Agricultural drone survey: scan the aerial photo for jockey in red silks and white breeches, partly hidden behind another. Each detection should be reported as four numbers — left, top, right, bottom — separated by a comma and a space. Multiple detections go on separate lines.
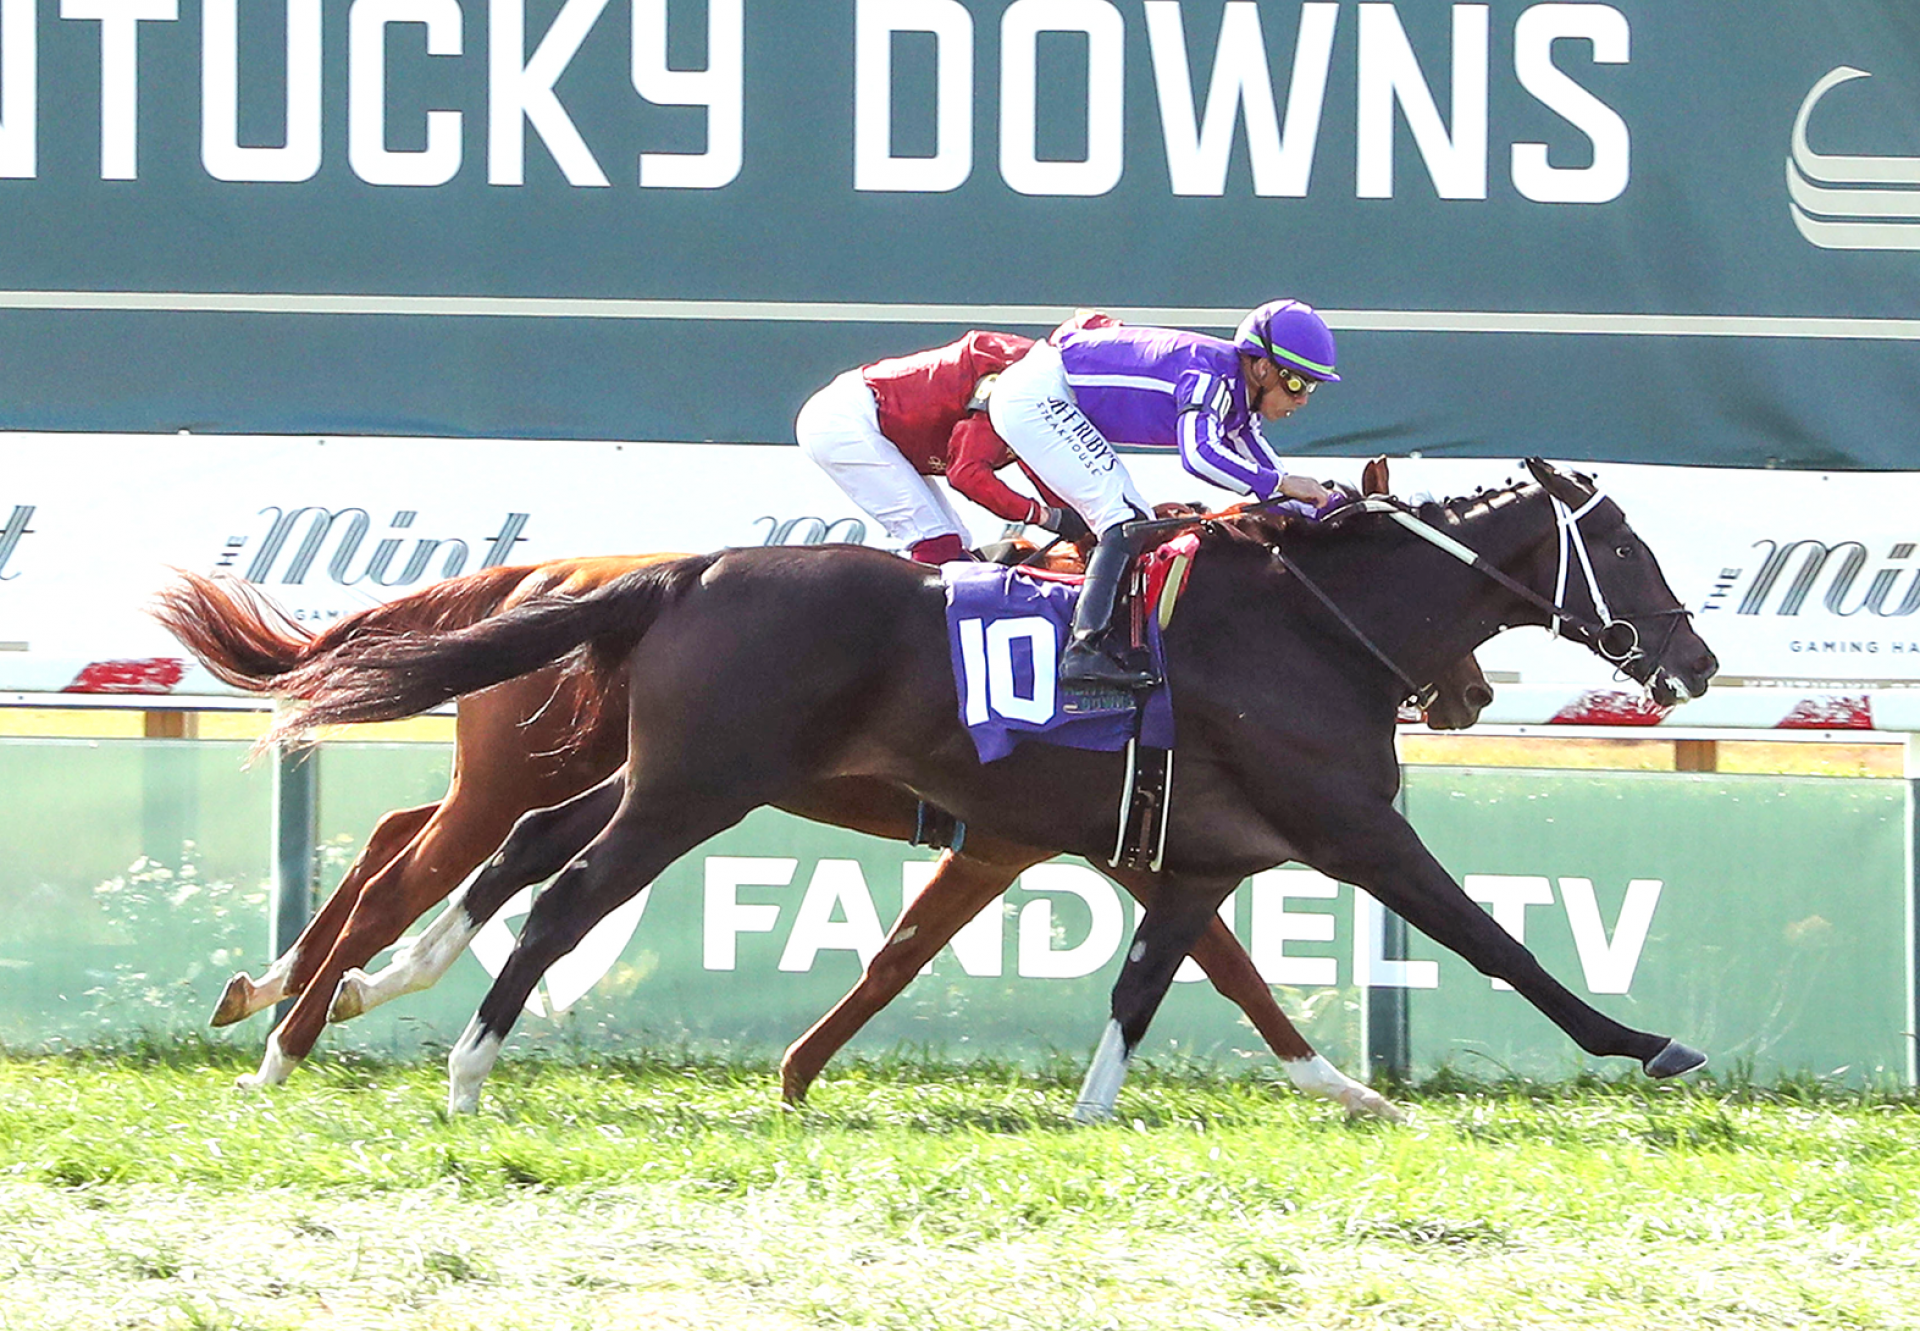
793, 313, 1112, 565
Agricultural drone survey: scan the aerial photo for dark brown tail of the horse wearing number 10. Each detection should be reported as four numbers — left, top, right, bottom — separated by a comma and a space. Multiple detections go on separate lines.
263, 555, 716, 743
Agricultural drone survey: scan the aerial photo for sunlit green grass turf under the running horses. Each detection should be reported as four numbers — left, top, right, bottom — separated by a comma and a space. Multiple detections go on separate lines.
0, 1049, 1920, 1331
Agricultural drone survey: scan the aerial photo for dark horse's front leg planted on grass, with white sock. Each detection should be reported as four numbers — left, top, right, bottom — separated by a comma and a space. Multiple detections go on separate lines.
1073, 874, 1238, 1124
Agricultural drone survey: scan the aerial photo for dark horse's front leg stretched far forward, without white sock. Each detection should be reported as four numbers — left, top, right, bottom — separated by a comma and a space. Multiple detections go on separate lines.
1296, 805, 1707, 1077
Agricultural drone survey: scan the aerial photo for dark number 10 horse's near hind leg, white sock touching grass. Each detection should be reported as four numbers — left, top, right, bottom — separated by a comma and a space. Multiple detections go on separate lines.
447, 787, 766, 1114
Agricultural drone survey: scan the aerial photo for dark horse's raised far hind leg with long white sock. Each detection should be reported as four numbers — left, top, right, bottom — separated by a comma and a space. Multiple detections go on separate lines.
328, 770, 626, 1022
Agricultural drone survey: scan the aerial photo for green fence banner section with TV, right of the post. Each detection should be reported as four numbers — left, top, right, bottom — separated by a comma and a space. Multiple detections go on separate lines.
1407, 768, 1912, 1081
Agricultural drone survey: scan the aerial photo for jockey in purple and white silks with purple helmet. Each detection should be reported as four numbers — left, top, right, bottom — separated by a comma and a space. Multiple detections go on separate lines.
989, 300, 1340, 690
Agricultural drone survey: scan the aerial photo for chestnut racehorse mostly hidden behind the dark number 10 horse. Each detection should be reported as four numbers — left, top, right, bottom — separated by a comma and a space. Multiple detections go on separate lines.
157, 545, 1492, 1114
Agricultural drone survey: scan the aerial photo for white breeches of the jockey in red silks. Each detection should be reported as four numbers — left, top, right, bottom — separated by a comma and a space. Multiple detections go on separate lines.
793, 371, 973, 545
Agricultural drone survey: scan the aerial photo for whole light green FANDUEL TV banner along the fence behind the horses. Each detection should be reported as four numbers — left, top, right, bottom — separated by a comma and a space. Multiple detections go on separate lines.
0, 741, 1910, 1081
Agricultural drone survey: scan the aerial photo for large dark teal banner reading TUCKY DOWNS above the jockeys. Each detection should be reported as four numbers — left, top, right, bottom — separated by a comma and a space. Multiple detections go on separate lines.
0, 0, 1920, 469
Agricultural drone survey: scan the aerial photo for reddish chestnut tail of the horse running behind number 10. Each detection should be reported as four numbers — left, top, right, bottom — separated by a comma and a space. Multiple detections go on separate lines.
152, 567, 549, 693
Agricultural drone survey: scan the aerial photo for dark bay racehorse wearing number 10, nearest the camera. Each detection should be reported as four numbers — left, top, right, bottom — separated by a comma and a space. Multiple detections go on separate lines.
263, 459, 1716, 1116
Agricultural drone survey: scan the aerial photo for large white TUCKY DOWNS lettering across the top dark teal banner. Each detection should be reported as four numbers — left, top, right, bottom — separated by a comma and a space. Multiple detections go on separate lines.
0, 0, 1632, 204
